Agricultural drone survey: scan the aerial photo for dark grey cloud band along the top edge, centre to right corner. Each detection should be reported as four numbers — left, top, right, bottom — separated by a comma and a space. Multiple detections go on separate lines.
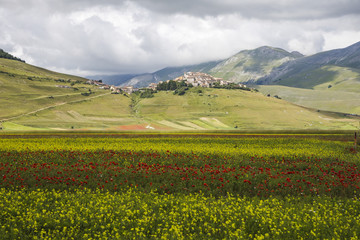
130, 0, 360, 19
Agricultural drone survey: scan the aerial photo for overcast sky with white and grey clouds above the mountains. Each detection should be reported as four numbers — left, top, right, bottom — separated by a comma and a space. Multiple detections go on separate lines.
0, 0, 360, 76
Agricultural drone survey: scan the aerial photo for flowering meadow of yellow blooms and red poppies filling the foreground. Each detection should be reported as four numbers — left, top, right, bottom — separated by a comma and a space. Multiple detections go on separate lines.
0, 133, 360, 239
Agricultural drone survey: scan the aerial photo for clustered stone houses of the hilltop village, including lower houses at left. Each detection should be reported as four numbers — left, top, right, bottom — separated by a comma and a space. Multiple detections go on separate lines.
86, 72, 246, 94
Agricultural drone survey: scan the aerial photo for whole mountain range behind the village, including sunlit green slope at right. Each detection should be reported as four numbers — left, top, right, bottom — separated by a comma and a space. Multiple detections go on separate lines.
88, 42, 360, 115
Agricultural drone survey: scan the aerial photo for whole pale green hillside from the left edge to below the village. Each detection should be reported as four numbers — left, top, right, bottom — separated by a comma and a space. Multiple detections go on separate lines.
0, 59, 358, 130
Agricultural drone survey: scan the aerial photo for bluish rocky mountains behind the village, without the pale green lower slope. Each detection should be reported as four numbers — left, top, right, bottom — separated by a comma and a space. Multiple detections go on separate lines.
96, 42, 360, 92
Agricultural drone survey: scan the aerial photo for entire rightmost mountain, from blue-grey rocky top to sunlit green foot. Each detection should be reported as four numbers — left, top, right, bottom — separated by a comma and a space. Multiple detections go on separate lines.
253, 42, 360, 115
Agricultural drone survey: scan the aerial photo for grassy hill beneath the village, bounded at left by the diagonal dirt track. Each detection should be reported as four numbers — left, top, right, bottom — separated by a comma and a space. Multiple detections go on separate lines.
3, 88, 358, 130
